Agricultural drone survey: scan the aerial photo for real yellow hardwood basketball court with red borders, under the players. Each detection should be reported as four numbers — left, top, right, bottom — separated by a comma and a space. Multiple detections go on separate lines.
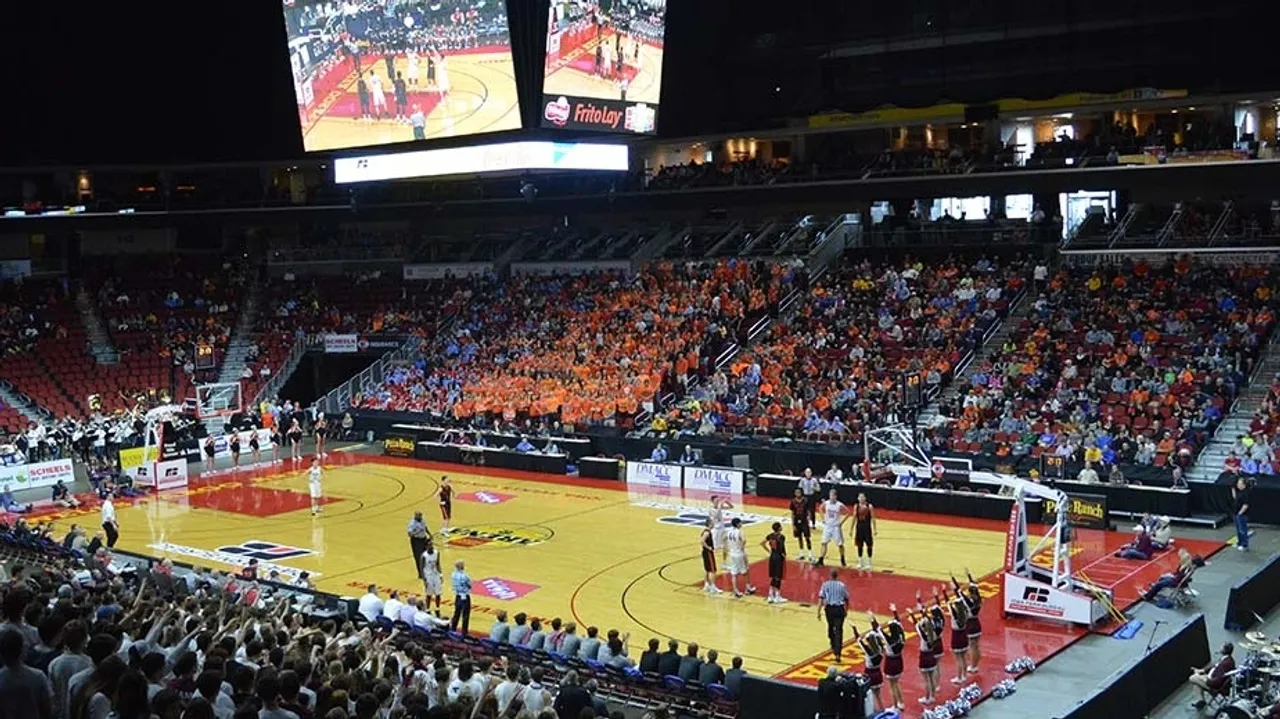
20, 452, 1224, 706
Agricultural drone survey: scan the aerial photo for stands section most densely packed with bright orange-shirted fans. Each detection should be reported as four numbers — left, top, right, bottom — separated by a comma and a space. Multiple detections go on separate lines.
362, 261, 796, 425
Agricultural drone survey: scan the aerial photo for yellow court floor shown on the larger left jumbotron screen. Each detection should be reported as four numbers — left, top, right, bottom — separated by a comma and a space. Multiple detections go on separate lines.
303, 52, 520, 150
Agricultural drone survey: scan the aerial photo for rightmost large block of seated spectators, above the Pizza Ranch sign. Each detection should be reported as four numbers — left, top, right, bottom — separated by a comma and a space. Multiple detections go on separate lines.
933, 258, 1276, 468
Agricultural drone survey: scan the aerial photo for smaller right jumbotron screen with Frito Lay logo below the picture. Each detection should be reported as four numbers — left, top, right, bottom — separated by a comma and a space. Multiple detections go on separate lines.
543, 0, 667, 133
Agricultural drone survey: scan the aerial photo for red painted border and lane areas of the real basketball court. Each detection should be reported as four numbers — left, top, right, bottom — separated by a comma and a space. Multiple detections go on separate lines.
10, 453, 1225, 709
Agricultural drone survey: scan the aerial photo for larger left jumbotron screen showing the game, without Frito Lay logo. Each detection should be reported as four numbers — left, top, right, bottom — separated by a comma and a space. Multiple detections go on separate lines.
283, 0, 521, 152
